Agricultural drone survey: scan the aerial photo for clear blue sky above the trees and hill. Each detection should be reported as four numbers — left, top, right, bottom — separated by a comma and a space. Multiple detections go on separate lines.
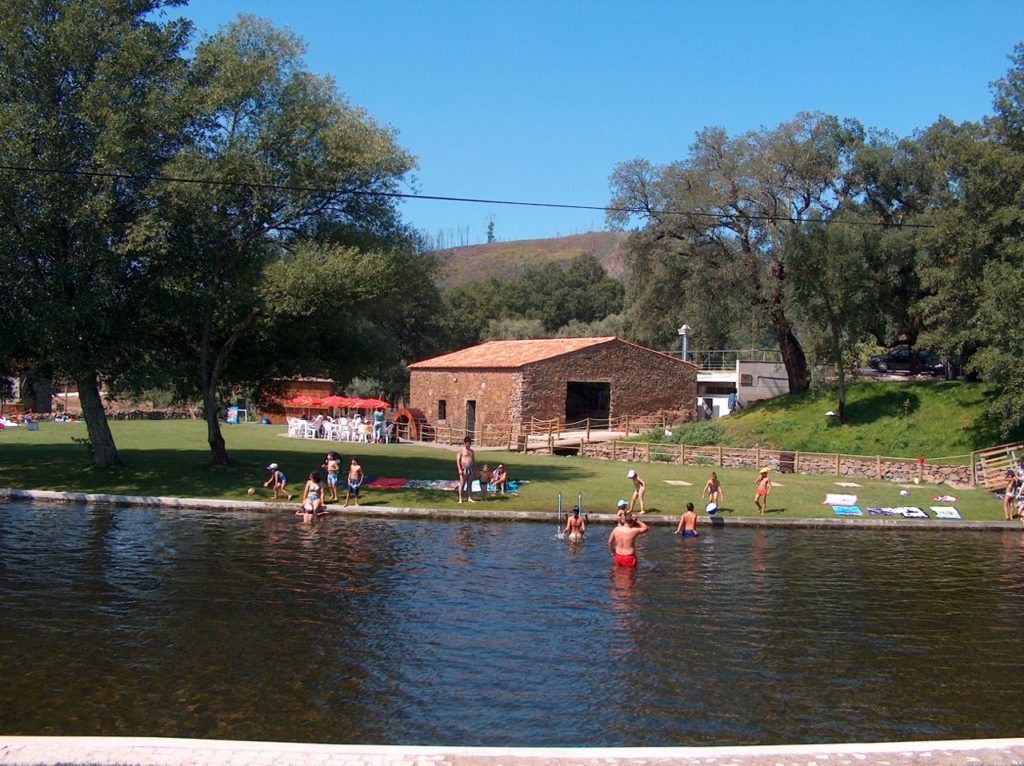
176, 0, 1024, 244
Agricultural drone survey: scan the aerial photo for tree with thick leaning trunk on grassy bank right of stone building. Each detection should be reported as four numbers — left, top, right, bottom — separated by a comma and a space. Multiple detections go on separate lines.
608, 114, 864, 392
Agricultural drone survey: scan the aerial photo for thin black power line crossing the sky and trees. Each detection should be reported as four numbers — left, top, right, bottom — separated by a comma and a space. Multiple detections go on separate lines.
0, 164, 935, 228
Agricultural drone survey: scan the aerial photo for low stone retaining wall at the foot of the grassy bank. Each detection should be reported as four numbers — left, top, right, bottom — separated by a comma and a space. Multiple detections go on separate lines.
582, 441, 973, 485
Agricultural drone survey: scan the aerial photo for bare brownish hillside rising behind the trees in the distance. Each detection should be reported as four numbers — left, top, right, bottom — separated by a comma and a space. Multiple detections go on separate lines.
436, 231, 630, 290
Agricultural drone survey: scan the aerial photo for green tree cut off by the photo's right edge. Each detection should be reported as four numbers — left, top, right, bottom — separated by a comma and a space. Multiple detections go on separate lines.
921, 44, 1024, 433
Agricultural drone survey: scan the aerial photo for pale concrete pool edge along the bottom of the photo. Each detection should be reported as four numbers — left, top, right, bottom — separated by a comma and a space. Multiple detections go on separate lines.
0, 736, 1024, 766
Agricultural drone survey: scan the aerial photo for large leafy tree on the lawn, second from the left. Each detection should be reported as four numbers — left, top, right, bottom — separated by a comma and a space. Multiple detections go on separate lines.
130, 15, 414, 464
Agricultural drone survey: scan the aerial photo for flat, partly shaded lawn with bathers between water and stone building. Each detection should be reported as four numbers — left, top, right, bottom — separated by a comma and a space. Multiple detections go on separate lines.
0, 421, 1002, 523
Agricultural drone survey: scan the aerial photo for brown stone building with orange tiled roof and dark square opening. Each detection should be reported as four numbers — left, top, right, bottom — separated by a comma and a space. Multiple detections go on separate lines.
410, 337, 696, 434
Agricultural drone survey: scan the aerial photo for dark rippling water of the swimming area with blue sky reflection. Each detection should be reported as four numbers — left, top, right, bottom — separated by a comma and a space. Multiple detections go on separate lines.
0, 504, 1024, 746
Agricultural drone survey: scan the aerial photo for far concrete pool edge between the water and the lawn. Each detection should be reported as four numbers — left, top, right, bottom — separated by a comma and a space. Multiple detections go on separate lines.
0, 487, 1024, 534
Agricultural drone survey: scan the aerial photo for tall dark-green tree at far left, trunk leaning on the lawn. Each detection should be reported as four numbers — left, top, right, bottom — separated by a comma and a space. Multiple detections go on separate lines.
0, 0, 189, 466
